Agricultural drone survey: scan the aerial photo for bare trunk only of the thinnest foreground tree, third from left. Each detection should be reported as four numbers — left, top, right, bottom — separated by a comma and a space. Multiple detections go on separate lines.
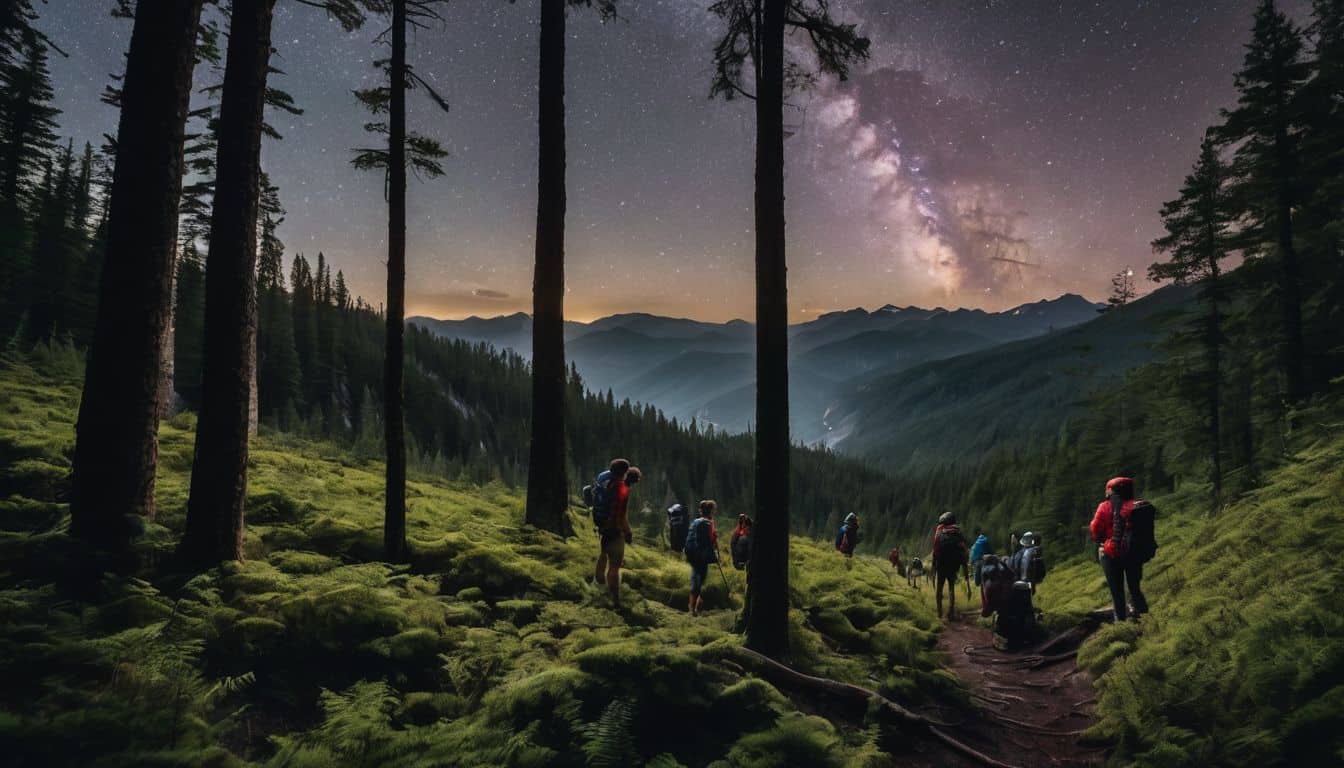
383, 0, 406, 562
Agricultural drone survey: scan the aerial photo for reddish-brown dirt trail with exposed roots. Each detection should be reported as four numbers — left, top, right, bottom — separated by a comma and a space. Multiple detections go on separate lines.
918, 612, 1106, 768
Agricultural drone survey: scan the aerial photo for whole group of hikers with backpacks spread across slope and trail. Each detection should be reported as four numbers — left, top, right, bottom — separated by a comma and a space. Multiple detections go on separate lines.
583, 459, 1157, 634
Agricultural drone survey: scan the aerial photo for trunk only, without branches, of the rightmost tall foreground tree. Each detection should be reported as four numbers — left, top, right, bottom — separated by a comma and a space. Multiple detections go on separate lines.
746, 0, 789, 658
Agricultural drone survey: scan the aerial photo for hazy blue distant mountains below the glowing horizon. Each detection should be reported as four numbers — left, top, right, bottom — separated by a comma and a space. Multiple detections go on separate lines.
407, 293, 1101, 444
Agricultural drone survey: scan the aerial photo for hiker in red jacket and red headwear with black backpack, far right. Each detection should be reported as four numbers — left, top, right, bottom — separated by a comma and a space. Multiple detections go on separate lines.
1091, 477, 1157, 623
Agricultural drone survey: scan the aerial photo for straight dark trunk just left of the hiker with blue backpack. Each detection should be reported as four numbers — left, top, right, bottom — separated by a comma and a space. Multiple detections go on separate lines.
526, 0, 574, 535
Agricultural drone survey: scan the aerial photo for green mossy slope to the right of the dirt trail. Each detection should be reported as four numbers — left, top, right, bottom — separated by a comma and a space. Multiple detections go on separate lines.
1040, 426, 1344, 765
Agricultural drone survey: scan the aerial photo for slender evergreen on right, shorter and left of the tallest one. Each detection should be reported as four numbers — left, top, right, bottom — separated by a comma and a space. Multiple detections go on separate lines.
1148, 136, 1234, 511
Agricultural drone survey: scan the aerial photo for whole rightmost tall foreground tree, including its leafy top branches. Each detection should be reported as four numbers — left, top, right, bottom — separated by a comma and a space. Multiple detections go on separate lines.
710, 0, 868, 656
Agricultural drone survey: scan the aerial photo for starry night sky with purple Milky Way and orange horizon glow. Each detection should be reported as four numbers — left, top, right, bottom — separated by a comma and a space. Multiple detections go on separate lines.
39, 0, 1306, 320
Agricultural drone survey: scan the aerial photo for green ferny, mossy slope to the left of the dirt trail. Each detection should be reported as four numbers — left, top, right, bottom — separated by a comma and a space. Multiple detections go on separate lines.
0, 360, 958, 765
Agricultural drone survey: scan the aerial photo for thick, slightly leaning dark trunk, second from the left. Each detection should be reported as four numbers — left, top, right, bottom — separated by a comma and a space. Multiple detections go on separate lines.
179, 0, 276, 568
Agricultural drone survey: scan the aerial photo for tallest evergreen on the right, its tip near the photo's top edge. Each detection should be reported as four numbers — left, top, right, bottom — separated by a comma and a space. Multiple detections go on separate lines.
1219, 0, 1310, 402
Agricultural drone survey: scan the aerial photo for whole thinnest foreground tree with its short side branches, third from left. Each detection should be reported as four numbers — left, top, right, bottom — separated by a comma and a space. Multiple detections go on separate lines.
353, 0, 448, 562
